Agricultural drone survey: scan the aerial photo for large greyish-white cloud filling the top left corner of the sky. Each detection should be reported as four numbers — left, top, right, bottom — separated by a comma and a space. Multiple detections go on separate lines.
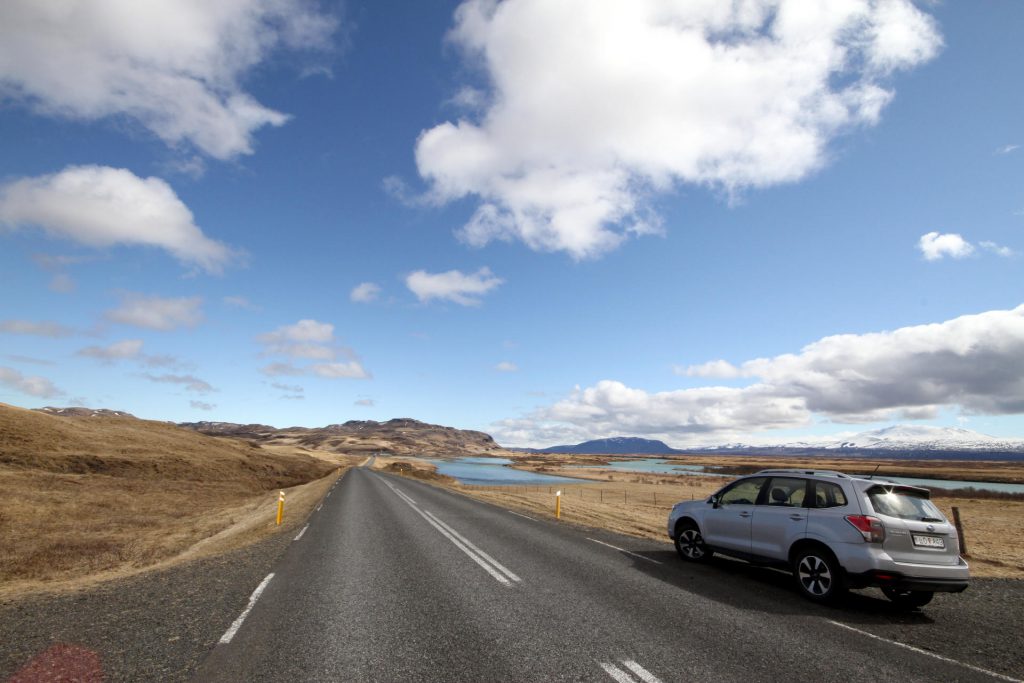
0, 0, 337, 159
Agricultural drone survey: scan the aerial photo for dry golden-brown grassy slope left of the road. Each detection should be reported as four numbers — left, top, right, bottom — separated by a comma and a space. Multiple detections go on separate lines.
0, 404, 354, 597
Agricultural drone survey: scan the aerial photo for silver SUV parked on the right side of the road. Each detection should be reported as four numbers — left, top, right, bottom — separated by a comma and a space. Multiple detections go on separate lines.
669, 470, 970, 607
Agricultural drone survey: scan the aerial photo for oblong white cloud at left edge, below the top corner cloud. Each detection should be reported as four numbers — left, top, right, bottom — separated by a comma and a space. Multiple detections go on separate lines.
0, 166, 234, 272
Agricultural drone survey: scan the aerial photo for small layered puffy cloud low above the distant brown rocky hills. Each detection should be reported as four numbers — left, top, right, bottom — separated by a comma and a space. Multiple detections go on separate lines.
257, 318, 370, 379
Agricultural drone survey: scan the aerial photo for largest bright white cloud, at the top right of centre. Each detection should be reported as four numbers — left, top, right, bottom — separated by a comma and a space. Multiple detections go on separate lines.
416, 0, 942, 259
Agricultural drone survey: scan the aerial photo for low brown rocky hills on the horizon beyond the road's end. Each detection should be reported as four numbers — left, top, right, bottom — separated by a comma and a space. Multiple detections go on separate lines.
180, 418, 509, 457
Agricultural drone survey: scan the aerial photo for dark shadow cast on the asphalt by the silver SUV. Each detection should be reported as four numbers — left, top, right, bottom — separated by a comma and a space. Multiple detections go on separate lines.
632, 550, 934, 626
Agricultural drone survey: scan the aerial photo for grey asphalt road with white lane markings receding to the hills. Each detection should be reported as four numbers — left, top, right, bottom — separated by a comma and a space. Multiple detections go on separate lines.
190, 469, 1024, 683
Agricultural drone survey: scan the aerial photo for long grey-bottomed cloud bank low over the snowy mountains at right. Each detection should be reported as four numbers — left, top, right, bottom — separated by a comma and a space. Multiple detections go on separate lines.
495, 305, 1024, 444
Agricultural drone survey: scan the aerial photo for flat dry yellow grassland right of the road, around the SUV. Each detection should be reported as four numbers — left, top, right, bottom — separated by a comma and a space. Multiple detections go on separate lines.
376, 456, 1024, 579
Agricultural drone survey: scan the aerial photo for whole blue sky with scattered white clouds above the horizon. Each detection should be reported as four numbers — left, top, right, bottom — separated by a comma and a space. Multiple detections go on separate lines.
0, 0, 1024, 445
